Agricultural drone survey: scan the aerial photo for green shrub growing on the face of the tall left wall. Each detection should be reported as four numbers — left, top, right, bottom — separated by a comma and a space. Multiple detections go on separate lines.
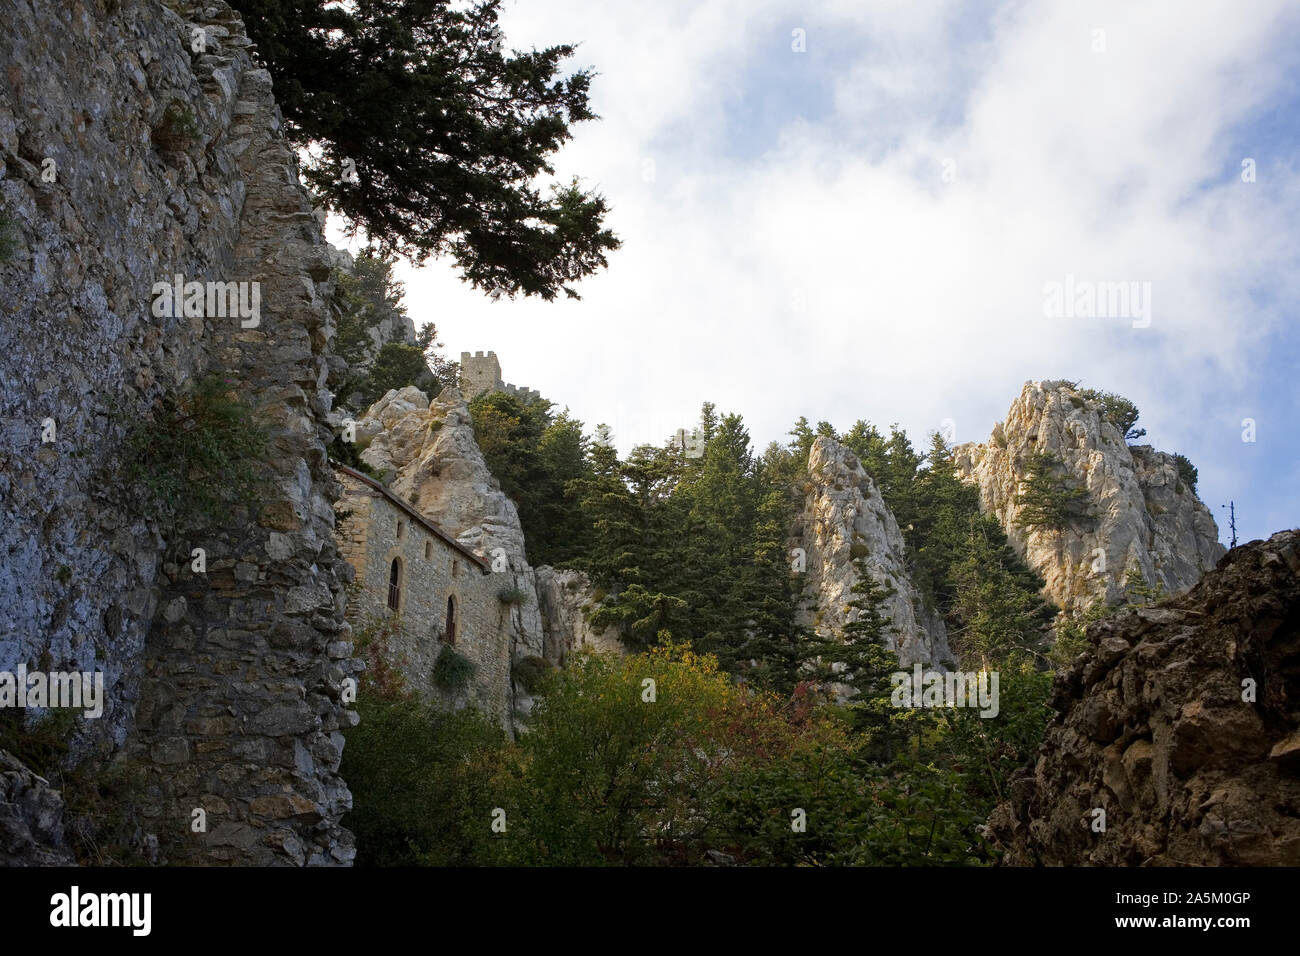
122, 376, 270, 535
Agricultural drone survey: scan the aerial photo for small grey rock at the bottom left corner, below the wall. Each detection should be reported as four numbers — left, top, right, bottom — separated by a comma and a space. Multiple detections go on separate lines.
0, 750, 75, 866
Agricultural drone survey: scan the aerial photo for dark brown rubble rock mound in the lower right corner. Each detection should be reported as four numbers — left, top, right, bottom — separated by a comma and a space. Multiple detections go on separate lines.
989, 531, 1300, 866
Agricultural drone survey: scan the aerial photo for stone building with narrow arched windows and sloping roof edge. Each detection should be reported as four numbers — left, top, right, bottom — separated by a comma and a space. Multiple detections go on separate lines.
335, 466, 511, 726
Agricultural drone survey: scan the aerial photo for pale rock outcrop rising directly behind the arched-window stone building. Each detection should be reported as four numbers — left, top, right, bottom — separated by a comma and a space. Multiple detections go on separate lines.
358, 386, 543, 712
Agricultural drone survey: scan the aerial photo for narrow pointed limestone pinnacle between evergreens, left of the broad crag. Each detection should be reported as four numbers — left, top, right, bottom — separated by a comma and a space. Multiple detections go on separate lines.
792, 437, 953, 666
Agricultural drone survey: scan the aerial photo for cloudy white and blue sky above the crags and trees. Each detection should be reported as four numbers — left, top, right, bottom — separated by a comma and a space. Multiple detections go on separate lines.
330, 0, 1300, 544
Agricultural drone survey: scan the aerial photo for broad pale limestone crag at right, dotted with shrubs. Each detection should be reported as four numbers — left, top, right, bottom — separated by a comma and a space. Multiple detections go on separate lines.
954, 382, 1225, 610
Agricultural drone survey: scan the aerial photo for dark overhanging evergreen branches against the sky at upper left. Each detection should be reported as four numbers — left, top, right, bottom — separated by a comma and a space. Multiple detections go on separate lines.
235, 0, 619, 299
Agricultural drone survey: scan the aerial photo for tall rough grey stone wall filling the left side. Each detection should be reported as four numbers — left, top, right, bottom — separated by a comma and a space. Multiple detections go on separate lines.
0, 0, 356, 865
